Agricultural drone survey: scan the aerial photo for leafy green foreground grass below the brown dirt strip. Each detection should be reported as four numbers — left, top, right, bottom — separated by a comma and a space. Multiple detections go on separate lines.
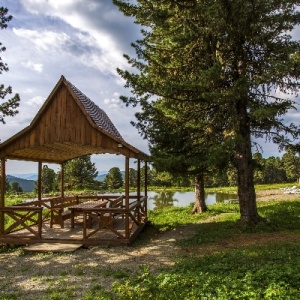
113, 243, 300, 300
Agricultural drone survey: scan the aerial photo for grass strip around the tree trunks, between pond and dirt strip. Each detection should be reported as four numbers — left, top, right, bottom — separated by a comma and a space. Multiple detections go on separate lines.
149, 201, 300, 247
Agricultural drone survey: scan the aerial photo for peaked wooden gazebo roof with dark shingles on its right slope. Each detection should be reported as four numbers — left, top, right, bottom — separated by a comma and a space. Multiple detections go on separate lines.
0, 76, 149, 163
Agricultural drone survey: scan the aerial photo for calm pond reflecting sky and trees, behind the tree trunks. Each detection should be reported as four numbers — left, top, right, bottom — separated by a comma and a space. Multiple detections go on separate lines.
148, 191, 237, 210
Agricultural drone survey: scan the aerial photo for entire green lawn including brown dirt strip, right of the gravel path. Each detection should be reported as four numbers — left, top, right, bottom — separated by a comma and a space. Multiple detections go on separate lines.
0, 198, 300, 300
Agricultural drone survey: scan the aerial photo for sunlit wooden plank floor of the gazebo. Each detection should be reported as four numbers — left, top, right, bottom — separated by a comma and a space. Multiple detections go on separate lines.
0, 219, 144, 247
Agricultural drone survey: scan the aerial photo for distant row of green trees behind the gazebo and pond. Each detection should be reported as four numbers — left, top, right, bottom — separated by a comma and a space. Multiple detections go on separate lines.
6, 149, 300, 194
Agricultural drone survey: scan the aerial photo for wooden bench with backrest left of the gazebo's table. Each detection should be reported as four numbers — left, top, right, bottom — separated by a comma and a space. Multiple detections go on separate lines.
50, 196, 79, 228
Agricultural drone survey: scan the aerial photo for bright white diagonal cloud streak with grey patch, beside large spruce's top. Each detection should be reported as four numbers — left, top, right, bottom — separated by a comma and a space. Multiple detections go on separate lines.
22, 0, 132, 68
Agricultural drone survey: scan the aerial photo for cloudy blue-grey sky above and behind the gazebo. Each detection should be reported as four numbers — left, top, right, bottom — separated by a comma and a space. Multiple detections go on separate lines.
0, 0, 300, 174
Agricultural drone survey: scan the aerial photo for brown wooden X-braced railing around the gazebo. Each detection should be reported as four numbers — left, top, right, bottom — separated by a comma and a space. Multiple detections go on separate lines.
0, 195, 147, 241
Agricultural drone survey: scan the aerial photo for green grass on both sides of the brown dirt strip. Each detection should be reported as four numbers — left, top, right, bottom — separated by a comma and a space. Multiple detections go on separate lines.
113, 200, 300, 300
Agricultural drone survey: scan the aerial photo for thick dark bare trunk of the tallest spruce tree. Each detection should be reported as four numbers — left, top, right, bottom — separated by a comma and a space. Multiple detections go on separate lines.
236, 100, 263, 224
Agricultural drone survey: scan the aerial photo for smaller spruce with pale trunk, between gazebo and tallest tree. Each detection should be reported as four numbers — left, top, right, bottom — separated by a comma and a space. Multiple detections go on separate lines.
135, 99, 232, 213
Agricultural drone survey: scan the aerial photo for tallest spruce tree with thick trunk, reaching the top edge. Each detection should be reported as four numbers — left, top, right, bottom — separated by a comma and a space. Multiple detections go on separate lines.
113, 0, 300, 223
